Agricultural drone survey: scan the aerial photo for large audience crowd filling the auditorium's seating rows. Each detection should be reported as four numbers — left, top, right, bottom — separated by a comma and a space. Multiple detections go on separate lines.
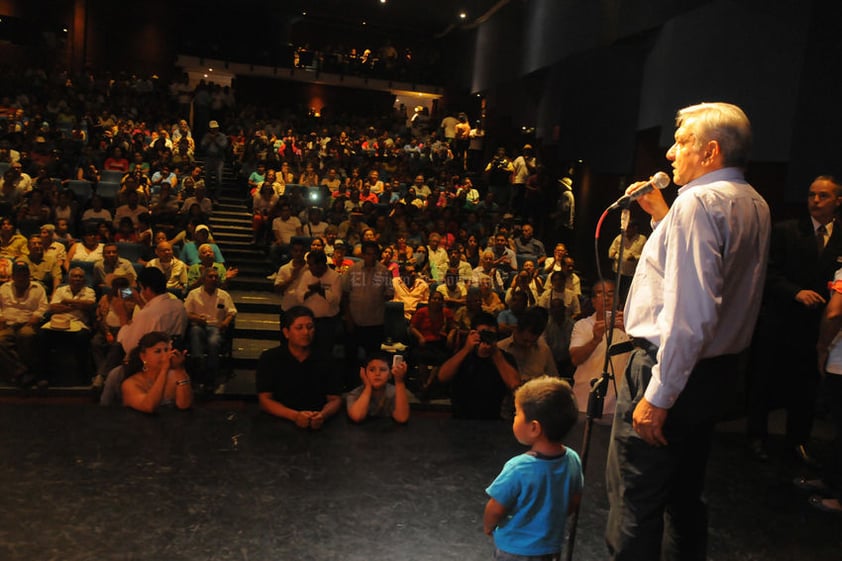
0, 62, 604, 424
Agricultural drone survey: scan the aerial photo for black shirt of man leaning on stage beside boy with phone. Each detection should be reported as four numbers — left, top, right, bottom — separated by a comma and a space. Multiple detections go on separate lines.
255, 346, 342, 411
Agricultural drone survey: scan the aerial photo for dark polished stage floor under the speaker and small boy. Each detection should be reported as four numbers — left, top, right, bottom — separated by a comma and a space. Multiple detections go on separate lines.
0, 402, 842, 561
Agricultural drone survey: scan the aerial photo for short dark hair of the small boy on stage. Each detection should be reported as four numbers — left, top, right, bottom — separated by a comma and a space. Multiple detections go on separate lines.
515, 376, 579, 442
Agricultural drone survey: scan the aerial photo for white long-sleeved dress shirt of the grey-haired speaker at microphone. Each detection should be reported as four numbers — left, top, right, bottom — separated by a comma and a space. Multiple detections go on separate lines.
625, 168, 771, 408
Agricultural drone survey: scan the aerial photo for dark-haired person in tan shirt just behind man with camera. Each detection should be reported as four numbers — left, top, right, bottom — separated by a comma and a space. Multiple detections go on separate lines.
499, 308, 558, 382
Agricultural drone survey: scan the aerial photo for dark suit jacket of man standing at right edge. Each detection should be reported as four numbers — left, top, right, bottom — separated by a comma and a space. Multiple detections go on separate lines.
759, 216, 842, 344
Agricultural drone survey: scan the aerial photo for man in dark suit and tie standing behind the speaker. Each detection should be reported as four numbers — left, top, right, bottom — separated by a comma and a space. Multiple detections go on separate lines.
748, 175, 842, 465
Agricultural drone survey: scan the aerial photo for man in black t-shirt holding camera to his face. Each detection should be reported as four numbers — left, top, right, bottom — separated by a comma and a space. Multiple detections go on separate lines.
438, 312, 520, 419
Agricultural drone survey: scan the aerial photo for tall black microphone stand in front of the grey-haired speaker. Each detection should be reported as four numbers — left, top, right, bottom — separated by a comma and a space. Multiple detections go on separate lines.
566, 205, 630, 561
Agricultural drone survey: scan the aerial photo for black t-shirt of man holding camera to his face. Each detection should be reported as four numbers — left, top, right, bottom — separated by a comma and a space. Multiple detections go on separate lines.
450, 350, 517, 419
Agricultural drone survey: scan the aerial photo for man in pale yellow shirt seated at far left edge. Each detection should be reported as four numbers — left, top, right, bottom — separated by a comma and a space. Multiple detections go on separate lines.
0, 259, 47, 384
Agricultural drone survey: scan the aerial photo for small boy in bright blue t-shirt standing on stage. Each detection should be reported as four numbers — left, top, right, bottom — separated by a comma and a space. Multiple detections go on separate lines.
483, 376, 584, 561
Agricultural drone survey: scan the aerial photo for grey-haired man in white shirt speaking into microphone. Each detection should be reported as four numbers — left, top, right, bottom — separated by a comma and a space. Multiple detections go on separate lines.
606, 103, 771, 561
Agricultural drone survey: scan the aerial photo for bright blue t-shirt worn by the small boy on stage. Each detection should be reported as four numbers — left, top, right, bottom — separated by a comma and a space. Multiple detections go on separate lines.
485, 448, 584, 555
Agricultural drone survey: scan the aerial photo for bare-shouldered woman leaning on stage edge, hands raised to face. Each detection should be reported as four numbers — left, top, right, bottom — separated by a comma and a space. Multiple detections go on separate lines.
121, 331, 193, 413
